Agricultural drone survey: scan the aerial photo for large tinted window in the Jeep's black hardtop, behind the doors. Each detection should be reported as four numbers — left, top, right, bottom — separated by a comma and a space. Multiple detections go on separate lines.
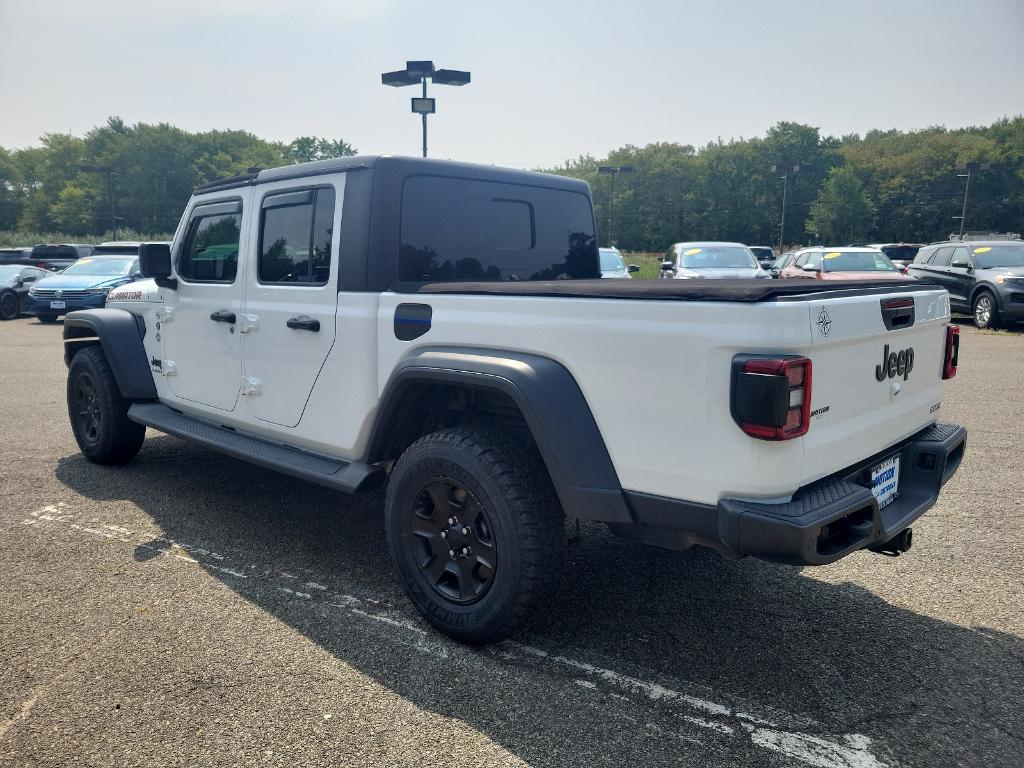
398, 176, 601, 283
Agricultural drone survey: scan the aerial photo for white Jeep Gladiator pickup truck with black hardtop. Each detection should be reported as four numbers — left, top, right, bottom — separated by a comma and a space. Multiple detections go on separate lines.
63, 157, 966, 642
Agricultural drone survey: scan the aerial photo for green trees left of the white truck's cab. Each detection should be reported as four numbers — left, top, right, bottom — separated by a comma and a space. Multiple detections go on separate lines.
0, 117, 355, 236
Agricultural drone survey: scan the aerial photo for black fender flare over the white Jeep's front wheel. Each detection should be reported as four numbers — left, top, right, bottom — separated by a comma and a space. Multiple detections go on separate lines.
63, 308, 157, 400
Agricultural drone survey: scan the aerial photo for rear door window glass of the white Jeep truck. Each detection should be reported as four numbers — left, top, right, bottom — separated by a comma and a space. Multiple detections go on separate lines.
257, 187, 334, 286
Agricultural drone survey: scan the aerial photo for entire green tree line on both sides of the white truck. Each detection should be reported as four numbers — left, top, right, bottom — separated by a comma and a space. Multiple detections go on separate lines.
0, 117, 1024, 251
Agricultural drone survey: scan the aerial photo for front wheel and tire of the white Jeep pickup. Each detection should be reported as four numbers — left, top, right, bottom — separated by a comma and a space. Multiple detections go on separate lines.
68, 346, 145, 464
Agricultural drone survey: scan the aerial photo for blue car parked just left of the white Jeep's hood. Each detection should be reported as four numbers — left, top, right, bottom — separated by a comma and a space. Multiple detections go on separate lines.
29, 254, 142, 323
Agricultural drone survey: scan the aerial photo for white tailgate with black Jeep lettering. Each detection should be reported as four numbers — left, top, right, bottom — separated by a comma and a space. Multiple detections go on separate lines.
803, 286, 949, 482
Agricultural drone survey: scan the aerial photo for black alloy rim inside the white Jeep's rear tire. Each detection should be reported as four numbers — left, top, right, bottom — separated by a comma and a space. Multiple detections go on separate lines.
409, 477, 498, 605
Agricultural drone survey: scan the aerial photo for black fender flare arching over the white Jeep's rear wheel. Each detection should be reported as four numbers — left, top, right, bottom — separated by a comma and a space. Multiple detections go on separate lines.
367, 348, 633, 522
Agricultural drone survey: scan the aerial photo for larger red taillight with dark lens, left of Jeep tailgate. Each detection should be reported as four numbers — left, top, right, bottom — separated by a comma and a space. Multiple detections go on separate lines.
731, 355, 811, 440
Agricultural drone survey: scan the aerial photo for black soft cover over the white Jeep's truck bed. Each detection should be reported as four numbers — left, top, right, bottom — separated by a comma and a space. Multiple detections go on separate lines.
391, 279, 937, 302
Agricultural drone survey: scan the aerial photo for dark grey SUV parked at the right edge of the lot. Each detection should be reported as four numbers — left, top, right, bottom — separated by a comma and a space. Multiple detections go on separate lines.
909, 240, 1024, 328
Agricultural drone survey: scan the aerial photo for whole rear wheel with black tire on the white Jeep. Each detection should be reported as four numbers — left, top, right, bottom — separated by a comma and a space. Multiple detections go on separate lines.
385, 427, 565, 643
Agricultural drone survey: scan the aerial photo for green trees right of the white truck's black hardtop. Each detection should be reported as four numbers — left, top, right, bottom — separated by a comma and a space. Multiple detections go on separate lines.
547, 117, 1024, 251
